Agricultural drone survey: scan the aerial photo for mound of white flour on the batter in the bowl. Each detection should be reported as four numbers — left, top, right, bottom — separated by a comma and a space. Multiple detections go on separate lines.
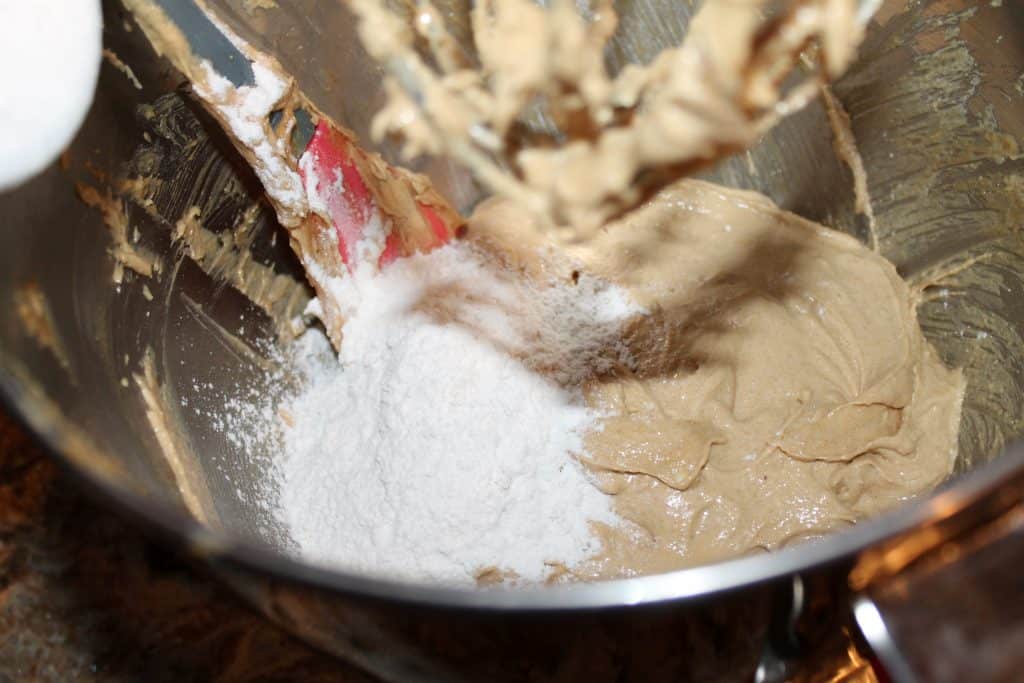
280, 245, 636, 584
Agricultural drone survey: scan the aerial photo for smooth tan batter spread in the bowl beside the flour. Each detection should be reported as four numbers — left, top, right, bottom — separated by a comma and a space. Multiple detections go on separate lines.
470, 180, 964, 579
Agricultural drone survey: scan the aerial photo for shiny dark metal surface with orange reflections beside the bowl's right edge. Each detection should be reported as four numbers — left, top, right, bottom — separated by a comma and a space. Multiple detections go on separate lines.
850, 438, 1024, 683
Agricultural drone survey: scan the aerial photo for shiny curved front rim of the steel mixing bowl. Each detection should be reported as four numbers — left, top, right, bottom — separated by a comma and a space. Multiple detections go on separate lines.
0, 359, 1024, 612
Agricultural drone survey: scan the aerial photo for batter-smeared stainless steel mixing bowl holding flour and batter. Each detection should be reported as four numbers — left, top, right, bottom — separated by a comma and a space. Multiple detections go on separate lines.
0, 0, 1024, 680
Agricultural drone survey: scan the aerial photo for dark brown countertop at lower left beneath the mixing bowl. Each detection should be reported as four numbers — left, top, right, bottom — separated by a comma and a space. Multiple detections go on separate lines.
0, 413, 371, 683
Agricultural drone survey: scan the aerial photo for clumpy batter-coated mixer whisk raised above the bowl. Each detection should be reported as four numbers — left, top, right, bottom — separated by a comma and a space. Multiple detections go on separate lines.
349, 0, 864, 233
